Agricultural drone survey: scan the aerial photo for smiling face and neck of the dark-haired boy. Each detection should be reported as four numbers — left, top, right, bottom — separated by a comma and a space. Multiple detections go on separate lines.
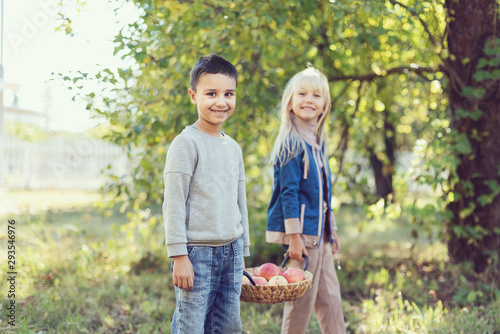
189, 73, 236, 136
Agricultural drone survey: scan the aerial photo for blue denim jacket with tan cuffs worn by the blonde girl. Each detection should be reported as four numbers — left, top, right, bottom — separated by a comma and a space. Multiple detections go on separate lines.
266, 142, 337, 248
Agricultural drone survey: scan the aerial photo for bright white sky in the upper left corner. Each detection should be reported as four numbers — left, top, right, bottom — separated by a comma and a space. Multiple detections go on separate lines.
0, 0, 138, 132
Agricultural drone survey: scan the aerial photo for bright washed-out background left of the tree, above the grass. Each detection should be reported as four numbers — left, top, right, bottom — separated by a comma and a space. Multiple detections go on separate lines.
0, 0, 138, 193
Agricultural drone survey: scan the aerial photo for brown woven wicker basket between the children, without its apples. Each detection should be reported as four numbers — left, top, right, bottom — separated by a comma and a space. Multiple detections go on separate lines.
240, 257, 313, 304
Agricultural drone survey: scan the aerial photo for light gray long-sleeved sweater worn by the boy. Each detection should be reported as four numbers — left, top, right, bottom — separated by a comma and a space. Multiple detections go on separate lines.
163, 126, 250, 257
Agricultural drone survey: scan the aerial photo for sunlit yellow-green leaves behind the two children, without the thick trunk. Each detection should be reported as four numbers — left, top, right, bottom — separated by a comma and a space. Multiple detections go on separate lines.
55, 0, 454, 256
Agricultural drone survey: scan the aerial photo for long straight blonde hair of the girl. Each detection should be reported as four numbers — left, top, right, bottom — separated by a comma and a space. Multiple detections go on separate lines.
271, 67, 331, 170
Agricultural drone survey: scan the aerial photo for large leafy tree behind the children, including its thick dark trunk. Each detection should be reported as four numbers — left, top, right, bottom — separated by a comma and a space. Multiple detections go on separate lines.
60, 0, 499, 270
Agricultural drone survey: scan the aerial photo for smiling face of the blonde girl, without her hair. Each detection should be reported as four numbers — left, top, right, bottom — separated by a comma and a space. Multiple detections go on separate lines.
288, 87, 325, 123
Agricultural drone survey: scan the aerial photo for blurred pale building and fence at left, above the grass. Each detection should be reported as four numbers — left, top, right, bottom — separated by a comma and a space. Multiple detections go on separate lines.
0, 78, 128, 189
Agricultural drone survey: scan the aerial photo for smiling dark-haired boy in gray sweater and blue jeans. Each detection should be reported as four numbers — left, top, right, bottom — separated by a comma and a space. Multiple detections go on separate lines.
163, 55, 250, 334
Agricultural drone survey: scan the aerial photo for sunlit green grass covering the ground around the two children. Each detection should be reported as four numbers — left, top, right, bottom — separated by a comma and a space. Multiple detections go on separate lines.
0, 191, 500, 334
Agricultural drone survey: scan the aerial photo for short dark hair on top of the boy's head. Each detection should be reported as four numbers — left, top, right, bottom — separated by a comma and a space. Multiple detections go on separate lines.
189, 54, 238, 90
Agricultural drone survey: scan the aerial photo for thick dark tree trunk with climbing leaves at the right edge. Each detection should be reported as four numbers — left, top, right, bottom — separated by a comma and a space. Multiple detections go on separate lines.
443, 0, 500, 272
